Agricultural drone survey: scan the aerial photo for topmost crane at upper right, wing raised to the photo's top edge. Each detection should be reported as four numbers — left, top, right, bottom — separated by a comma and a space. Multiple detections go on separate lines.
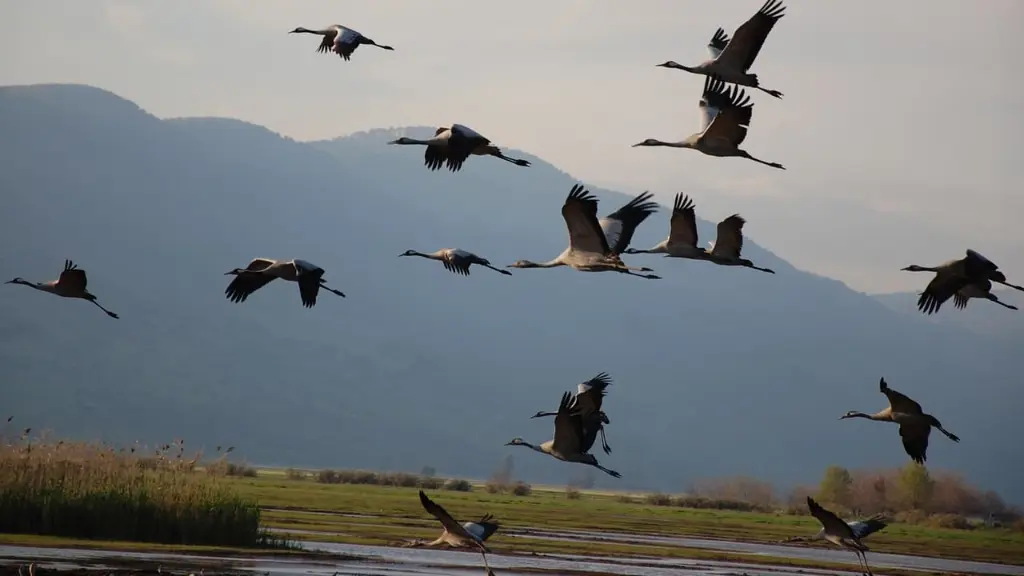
657, 0, 785, 98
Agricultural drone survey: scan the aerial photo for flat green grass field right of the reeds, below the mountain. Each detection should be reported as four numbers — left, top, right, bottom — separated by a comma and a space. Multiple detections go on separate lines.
232, 475, 1024, 564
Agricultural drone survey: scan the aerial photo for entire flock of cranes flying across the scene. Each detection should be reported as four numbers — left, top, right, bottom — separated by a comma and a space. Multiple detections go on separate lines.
7, 0, 1024, 574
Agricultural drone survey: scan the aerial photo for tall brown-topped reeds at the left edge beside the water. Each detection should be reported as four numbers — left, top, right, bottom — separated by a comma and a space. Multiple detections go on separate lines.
0, 438, 275, 546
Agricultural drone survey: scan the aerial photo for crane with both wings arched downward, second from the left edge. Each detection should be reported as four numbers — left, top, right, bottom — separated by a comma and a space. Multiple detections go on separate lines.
224, 258, 345, 308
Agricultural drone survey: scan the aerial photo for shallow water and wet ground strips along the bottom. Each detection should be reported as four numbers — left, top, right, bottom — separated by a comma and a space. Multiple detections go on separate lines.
0, 530, 1024, 576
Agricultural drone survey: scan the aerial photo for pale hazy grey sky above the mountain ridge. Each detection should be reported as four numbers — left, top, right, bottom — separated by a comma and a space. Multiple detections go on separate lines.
0, 0, 1024, 291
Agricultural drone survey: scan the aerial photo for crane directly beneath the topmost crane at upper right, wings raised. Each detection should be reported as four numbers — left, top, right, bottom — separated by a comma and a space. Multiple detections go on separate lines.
633, 76, 785, 170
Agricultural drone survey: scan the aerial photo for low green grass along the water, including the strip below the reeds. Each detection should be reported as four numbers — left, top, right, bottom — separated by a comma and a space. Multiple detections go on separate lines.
0, 461, 1024, 575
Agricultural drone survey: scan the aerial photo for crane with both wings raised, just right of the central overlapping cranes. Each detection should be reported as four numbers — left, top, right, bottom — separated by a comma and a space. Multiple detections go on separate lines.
626, 194, 775, 274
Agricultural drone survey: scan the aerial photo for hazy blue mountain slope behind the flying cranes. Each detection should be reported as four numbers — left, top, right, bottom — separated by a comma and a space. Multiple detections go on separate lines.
0, 85, 1024, 501
